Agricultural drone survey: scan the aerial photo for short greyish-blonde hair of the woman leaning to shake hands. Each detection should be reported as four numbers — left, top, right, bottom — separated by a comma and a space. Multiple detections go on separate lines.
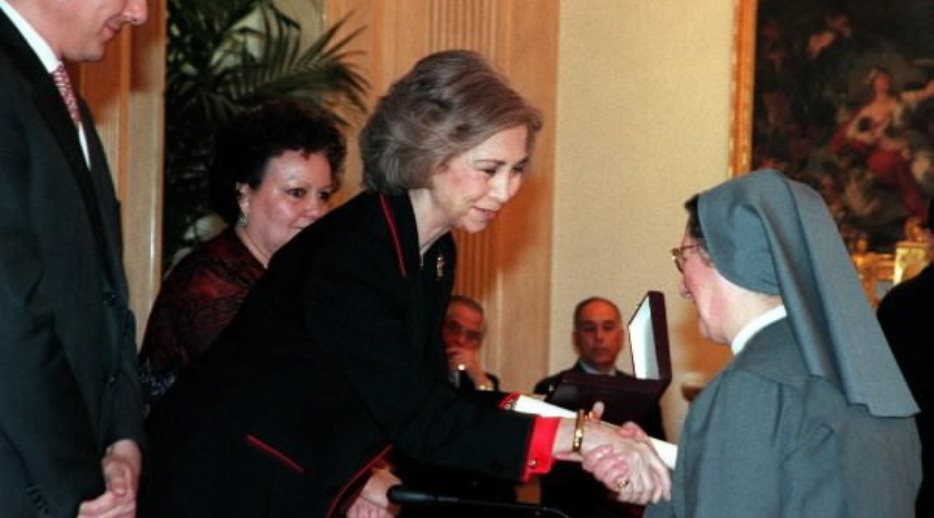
360, 50, 541, 193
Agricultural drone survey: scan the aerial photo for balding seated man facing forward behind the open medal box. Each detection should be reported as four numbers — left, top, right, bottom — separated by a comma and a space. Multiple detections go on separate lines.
534, 297, 665, 518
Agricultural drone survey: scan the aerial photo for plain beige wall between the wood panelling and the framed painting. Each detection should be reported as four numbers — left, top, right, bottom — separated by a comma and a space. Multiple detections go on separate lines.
549, 0, 734, 435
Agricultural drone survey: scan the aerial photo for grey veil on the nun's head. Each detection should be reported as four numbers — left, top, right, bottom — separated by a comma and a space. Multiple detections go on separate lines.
697, 171, 918, 417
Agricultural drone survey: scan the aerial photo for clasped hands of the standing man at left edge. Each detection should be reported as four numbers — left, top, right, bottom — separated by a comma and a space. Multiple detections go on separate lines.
78, 439, 143, 518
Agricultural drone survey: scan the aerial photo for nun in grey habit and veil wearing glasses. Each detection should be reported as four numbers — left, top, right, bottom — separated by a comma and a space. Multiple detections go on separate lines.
636, 171, 921, 518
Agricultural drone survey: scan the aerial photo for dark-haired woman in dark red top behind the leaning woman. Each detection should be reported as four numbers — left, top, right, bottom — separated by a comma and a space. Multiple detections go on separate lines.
139, 100, 346, 408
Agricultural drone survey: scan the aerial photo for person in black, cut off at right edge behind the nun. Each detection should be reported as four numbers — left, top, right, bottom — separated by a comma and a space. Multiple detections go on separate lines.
877, 202, 934, 518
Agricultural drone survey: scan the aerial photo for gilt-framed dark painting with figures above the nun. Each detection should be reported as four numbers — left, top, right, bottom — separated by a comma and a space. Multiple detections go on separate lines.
730, 0, 934, 254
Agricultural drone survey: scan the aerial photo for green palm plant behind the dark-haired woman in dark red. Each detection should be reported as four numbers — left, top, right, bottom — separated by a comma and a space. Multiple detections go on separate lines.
162, 0, 369, 269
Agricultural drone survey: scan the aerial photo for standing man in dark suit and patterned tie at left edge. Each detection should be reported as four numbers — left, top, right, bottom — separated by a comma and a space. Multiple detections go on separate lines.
0, 0, 147, 517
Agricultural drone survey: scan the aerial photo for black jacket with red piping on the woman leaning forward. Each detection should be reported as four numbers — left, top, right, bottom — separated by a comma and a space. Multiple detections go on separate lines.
141, 193, 532, 517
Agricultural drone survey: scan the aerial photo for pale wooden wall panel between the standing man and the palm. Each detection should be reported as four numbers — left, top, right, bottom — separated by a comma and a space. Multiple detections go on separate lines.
77, 0, 165, 350
